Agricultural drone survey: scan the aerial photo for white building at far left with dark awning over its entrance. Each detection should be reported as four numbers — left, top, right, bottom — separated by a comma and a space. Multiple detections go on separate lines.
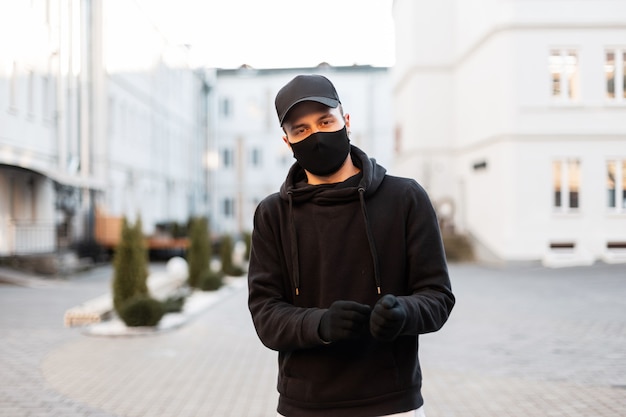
0, 1, 102, 256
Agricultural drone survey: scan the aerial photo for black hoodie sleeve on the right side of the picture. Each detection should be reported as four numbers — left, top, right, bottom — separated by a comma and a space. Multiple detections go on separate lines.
399, 181, 455, 335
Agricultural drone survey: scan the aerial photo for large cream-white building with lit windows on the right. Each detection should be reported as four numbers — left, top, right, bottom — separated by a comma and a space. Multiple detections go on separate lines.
392, 0, 626, 265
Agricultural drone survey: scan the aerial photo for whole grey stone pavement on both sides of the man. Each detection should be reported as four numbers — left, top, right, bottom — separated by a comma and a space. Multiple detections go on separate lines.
0, 264, 626, 417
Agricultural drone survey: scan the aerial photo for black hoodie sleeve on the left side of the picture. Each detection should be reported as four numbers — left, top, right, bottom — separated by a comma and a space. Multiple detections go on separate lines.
248, 201, 326, 351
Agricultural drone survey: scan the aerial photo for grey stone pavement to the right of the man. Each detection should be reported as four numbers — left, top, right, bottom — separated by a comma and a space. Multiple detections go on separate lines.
414, 264, 626, 417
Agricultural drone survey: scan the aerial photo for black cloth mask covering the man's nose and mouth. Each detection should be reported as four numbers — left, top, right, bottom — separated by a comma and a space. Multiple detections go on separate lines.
291, 126, 350, 176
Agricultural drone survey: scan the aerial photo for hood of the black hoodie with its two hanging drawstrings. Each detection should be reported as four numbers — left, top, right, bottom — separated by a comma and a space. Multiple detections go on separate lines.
280, 145, 387, 295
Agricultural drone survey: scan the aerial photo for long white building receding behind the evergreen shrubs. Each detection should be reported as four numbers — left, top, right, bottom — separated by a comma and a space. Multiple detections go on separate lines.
97, 0, 212, 234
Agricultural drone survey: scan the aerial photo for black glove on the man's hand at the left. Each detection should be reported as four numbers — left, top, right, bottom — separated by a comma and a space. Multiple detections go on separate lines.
319, 300, 371, 342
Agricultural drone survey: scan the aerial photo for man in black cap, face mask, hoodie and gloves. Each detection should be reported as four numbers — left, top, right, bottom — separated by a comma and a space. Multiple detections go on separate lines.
248, 75, 455, 417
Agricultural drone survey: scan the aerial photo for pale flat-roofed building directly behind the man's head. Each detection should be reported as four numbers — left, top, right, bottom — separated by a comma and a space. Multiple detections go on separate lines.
211, 64, 393, 234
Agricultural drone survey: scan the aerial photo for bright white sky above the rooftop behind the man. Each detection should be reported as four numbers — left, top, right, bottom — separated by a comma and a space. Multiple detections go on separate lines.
134, 0, 395, 68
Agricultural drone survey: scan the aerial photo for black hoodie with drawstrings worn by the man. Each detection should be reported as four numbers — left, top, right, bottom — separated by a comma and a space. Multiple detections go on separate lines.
248, 146, 455, 417
